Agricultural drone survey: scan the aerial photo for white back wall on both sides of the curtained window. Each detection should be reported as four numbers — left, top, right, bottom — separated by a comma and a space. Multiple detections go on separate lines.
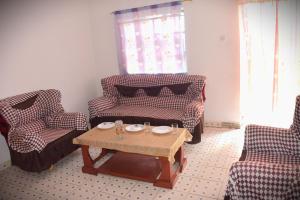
92, 0, 240, 123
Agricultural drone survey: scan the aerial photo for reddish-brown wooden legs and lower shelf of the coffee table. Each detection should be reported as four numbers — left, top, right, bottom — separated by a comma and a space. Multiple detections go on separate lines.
81, 145, 186, 189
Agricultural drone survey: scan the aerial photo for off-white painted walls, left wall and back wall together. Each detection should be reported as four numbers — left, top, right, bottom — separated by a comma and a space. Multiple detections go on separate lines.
0, 0, 239, 164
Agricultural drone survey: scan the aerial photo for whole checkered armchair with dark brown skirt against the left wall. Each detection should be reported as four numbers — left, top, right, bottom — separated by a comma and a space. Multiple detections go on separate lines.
0, 89, 87, 171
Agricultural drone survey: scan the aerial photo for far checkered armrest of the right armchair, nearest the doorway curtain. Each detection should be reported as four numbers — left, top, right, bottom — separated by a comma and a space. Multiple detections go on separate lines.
244, 125, 300, 156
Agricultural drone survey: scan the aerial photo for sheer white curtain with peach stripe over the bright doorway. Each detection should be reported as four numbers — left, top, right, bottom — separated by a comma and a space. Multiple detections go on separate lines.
239, 0, 300, 126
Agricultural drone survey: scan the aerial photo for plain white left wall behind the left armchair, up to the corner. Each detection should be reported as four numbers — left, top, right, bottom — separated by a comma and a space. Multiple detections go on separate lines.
0, 0, 96, 163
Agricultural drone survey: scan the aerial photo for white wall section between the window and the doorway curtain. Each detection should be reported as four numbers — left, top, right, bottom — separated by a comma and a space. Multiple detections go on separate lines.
184, 0, 240, 123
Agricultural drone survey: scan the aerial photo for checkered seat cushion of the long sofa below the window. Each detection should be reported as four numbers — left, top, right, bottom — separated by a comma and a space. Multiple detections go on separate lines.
98, 104, 183, 120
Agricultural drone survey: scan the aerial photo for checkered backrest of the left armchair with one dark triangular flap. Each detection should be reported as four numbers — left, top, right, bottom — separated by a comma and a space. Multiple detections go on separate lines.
0, 89, 63, 139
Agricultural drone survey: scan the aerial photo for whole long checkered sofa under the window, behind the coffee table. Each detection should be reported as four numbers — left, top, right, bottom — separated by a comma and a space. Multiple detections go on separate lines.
89, 74, 206, 143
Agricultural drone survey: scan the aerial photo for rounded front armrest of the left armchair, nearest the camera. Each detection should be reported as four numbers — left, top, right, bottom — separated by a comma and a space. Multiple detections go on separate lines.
8, 130, 47, 153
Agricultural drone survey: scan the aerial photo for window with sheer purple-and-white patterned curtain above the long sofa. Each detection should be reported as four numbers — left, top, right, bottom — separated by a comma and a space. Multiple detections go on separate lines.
114, 2, 187, 74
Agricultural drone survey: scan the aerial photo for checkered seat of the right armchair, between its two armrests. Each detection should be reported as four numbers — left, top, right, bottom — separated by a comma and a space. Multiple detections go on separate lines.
245, 151, 300, 165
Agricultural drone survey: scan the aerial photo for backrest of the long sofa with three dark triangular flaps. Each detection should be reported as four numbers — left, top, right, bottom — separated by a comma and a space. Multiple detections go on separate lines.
101, 74, 206, 100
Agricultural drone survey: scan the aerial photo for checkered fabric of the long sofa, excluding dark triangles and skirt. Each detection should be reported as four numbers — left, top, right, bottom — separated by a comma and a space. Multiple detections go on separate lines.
89, 74, 206, 132
